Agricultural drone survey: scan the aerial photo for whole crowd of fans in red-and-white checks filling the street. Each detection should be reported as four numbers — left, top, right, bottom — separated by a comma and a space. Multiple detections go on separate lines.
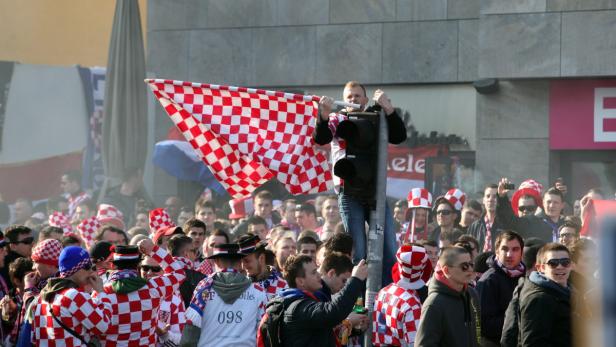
0, 82, 603, 347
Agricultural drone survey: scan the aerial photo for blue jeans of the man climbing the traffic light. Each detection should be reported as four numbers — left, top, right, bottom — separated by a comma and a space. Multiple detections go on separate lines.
338, 192, 398, 287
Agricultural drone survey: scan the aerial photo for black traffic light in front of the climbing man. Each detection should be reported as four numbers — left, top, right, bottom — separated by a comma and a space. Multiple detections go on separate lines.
334, 112, 379, 201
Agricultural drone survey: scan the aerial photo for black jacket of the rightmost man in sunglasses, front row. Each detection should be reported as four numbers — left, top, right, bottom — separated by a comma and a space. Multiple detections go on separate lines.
520, 272, 572, 347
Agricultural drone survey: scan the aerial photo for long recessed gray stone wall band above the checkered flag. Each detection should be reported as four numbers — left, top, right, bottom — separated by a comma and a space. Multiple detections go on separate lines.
148, 0, 479, 87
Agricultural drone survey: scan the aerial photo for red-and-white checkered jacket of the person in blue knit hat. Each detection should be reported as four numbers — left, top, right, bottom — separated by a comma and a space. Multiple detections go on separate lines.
32, 288, 112, 347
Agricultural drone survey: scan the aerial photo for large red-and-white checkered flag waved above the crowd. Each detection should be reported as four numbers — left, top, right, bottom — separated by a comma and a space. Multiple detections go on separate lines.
146, 80, 332, 198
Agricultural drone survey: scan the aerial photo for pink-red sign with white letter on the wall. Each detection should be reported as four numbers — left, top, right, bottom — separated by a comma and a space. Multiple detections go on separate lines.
550, 79, 616, 149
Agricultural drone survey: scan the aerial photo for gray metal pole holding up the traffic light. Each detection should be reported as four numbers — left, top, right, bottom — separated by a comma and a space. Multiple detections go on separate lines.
364, 111, 389, 346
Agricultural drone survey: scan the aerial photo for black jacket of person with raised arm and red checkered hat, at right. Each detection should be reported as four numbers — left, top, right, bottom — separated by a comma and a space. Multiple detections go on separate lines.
496, 196, 564, 242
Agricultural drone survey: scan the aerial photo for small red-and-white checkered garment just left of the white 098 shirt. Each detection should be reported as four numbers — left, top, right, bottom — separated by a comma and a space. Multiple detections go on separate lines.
157, 291, 186, 346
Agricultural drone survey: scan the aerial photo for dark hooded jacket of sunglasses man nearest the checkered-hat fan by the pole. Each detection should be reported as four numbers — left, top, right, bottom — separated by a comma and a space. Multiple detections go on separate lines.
415, 272, 480, 347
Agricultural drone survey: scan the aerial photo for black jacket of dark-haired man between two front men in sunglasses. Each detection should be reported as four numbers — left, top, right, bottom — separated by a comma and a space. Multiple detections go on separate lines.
477, 256, 524, 344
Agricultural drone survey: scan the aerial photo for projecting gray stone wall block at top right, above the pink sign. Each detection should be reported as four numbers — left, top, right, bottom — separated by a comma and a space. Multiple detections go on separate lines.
478, 0, 616, 78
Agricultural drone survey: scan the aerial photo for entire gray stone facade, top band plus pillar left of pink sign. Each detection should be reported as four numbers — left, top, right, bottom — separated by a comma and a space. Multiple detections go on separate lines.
147, 0, 616, 203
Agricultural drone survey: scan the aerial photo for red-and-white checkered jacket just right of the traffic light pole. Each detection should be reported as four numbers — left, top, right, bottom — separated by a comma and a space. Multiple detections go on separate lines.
372, 280, 421, 346
